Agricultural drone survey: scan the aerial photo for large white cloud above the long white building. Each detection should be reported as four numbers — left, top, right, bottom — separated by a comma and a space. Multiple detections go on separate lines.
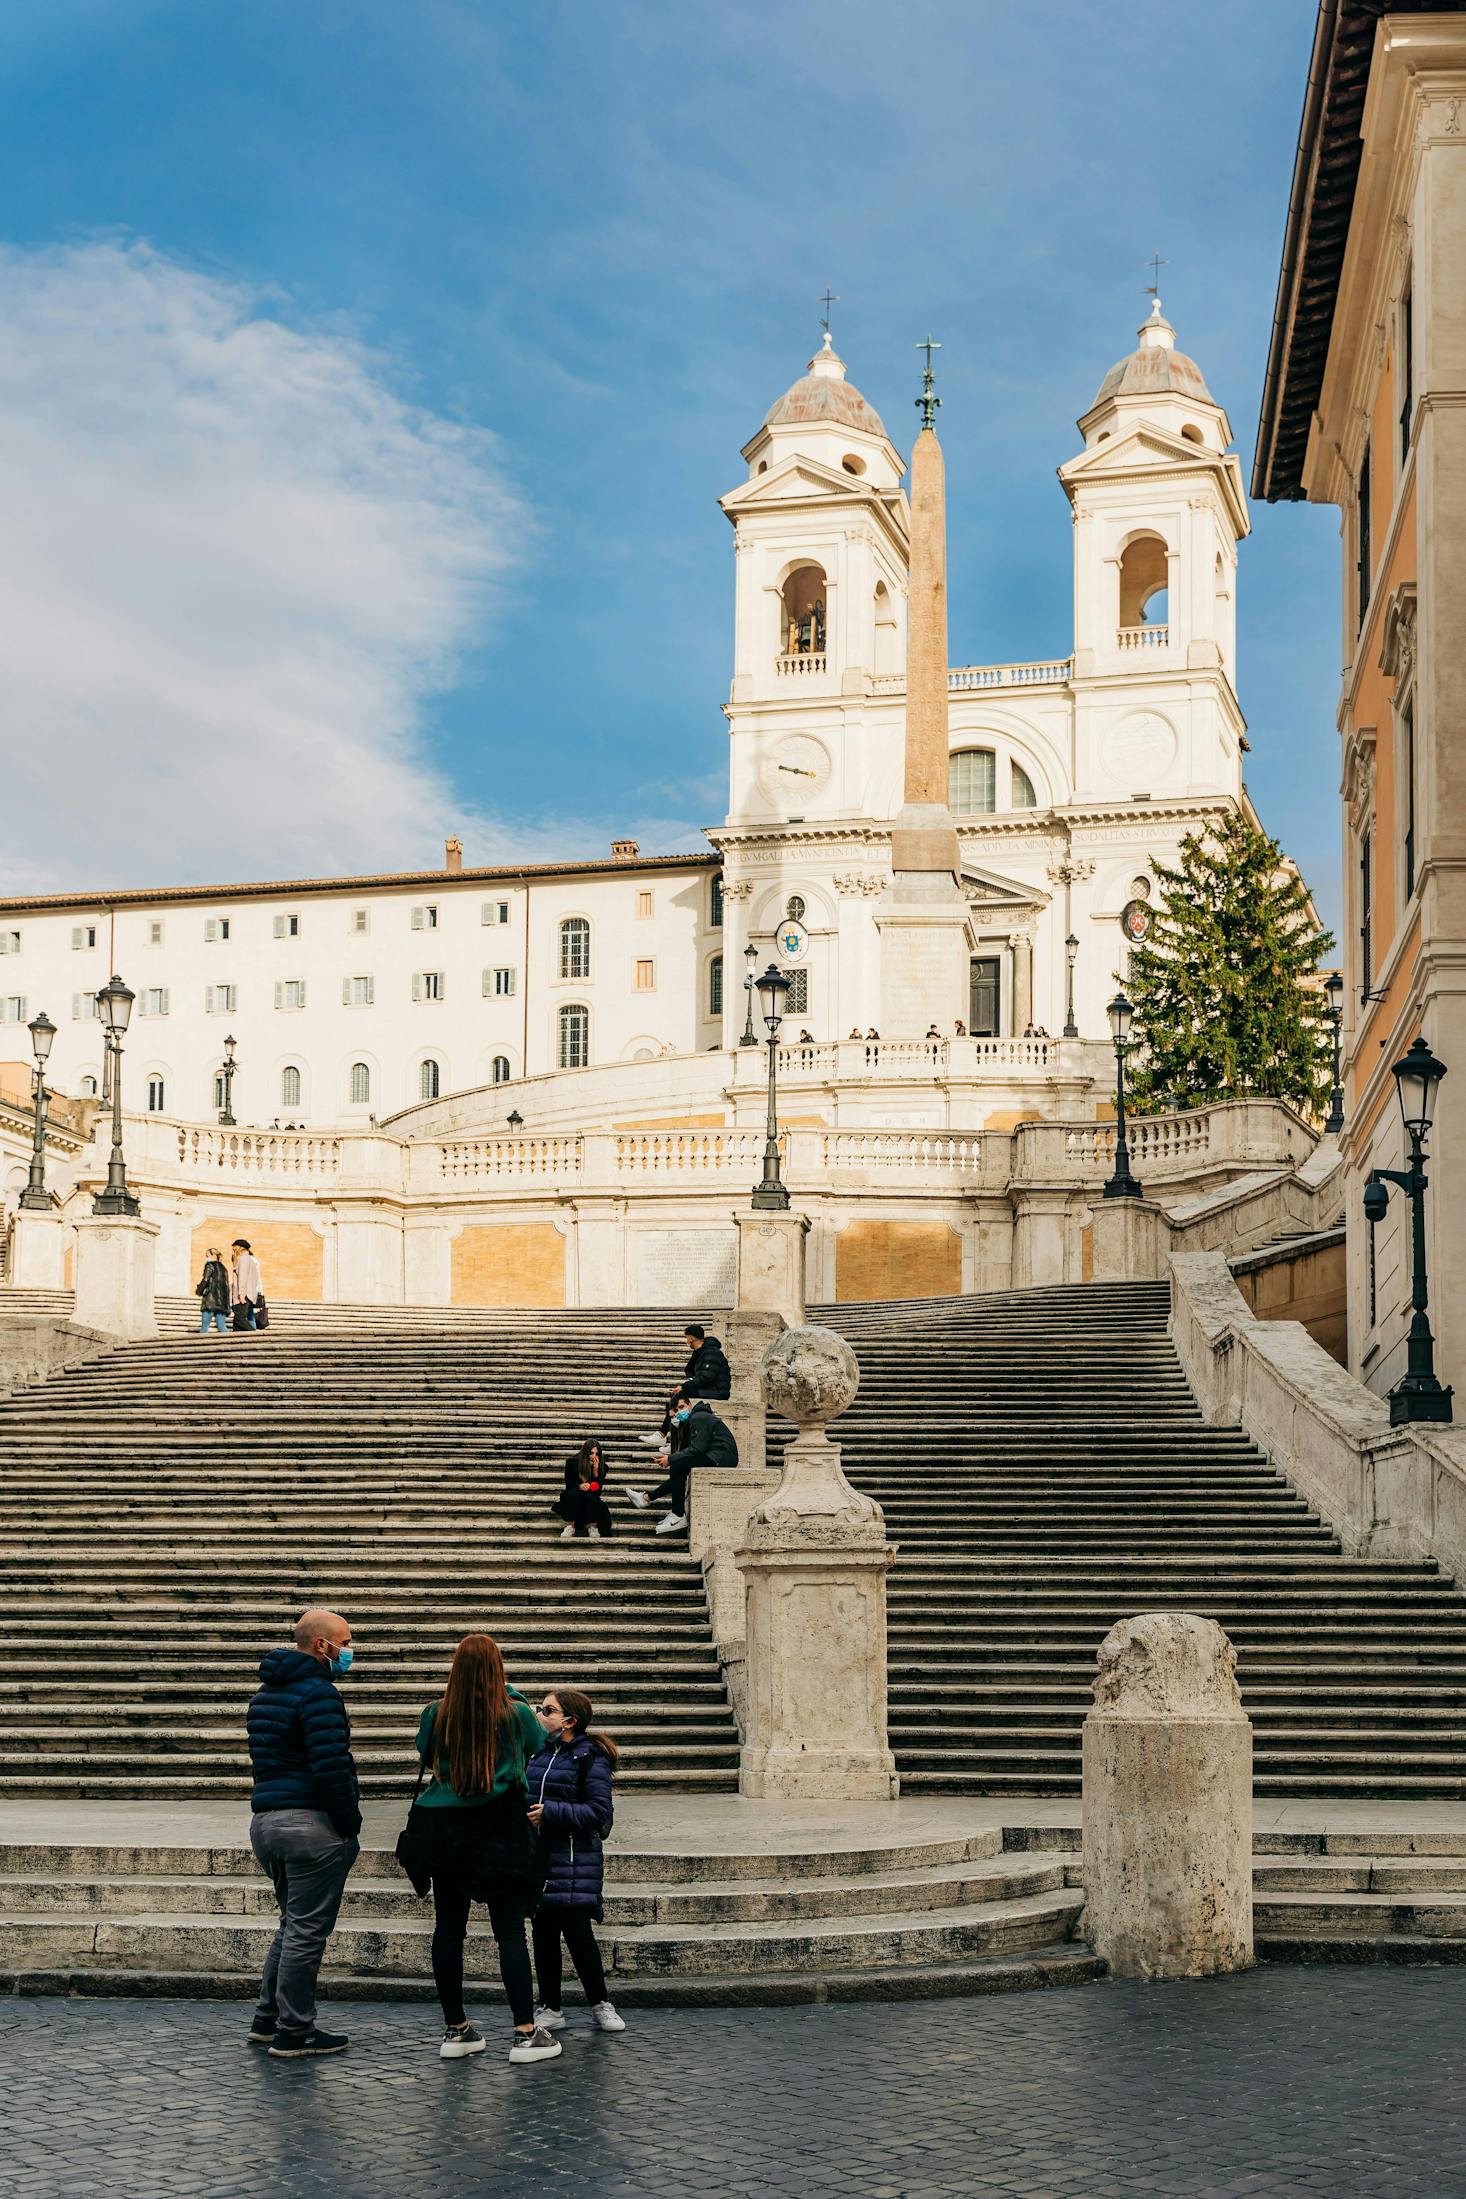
0, 242, 556, 893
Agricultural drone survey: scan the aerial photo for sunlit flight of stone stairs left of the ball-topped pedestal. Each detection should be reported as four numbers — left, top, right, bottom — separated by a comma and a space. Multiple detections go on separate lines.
0, 1293, 736, 1799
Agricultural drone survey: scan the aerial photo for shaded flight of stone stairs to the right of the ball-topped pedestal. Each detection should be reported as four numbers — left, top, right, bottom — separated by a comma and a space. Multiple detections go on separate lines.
826, 1284, 1466, 1799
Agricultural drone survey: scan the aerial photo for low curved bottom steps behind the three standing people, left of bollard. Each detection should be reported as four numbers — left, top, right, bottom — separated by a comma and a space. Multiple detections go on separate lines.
0, 1825, 1103, 2005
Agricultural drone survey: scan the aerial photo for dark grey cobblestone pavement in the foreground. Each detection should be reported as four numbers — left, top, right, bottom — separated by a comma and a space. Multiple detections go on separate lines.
0, 1968, 1466, 2199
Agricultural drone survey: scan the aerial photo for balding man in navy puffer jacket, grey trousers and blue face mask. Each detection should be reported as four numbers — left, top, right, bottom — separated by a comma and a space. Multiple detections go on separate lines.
246, 1610, 360, 2060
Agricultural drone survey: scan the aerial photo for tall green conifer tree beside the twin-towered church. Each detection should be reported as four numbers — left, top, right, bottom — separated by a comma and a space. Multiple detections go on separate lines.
1125, 814, 1334, 1117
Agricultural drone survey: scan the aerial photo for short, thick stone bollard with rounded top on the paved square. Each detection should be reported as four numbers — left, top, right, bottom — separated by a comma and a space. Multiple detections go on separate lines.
1081, 1612, 1253, 1977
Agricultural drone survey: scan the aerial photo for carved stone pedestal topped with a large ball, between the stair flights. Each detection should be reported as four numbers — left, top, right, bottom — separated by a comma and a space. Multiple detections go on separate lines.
734, 1328, 899, 1801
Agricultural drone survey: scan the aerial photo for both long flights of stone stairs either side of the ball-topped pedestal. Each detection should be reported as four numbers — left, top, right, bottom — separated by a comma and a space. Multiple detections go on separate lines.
0, 1284, 1466, 1799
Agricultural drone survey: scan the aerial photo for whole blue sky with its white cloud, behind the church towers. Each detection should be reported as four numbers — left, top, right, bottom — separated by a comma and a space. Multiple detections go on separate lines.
0, 0, 1339, 917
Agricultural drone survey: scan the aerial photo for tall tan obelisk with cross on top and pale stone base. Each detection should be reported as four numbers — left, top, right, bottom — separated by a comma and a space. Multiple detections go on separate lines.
875, 336, 971, 1038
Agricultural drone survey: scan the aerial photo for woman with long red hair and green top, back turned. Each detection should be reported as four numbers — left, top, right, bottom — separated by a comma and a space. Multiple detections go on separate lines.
413, 1634, 560, 2063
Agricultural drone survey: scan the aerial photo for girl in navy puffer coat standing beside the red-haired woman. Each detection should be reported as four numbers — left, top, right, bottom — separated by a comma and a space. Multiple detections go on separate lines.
525, 1687, 626, 2032
